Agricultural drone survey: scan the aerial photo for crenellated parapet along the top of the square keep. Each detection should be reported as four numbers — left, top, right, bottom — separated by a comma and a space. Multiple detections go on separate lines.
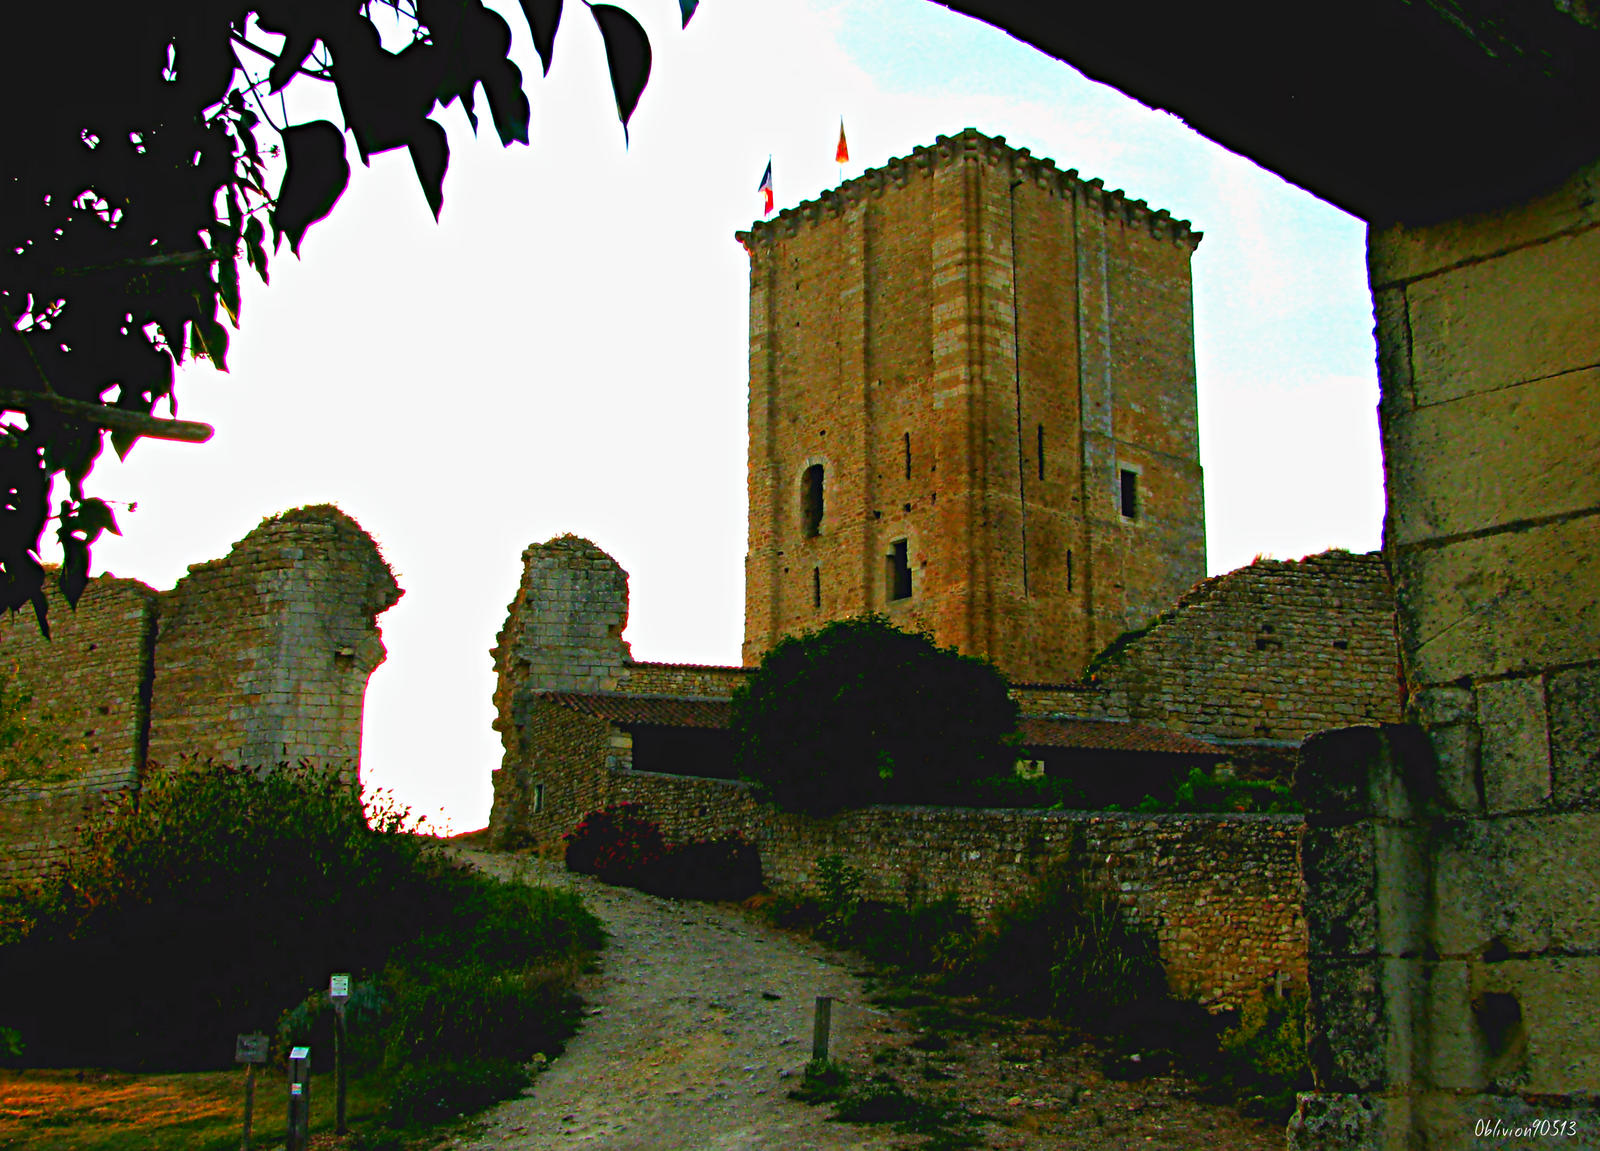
734, 128, 1205, 255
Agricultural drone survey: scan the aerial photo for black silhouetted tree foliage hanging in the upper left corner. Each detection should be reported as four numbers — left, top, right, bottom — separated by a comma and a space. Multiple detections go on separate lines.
0, 0, 681, 634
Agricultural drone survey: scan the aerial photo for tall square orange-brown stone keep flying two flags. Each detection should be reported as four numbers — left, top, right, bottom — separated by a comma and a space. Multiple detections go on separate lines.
739, 128, 1205, 682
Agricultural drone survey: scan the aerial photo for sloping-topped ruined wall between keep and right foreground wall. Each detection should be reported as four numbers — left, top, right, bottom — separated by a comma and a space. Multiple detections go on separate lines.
1094, 551, 1400, 744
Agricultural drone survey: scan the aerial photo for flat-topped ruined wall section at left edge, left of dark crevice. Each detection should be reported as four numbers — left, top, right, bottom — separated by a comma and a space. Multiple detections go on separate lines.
0, 576, 157, 882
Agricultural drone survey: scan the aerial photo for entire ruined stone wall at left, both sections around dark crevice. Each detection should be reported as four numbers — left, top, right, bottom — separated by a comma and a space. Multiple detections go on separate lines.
0, 504, 402, 879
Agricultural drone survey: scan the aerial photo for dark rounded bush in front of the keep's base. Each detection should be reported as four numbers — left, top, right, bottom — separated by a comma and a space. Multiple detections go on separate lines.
733, 615, 1018, 815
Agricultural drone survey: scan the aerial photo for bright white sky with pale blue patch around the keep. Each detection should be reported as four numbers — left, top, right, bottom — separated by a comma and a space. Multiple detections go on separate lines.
75, 0, 1382, 831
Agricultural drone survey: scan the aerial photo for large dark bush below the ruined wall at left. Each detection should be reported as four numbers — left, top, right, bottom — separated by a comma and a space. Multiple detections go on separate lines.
0, 765, 600, 1069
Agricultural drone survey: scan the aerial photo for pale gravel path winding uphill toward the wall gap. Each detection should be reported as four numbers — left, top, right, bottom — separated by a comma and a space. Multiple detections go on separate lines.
445, 850, 906, 1151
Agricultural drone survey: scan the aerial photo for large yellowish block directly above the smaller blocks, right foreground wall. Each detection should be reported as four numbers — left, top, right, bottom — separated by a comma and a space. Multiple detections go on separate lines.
1395, 515, 1600, 684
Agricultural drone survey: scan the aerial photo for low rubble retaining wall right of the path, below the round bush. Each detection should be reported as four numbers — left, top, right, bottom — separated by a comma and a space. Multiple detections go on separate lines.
610, 772, 1306, 1007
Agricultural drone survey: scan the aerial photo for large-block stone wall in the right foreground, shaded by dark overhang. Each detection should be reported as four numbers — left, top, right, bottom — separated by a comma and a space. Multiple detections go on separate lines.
1291, 163, 1600, 1151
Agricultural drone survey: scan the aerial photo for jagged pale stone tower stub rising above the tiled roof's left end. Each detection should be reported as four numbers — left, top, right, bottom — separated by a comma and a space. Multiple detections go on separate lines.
490, 535, 629, 764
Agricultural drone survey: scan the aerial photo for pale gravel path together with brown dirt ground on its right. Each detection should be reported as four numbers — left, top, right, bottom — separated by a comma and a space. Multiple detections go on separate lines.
440, 848, 1285, 1151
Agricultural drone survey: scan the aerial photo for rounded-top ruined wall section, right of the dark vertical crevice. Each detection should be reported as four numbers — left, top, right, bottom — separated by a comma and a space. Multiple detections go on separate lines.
149, 504, 400, 783
